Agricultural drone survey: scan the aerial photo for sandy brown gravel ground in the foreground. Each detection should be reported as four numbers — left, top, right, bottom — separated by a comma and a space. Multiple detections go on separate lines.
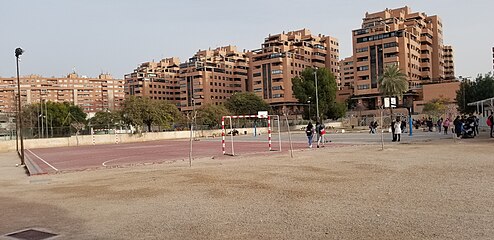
0, 138, 494, 239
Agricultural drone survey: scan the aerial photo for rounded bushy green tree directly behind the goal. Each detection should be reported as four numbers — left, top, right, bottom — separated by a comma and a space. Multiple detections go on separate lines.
225, 92, 270, 115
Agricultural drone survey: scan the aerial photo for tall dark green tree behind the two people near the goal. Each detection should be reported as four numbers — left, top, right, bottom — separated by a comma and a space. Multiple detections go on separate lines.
292, 68, 338, 120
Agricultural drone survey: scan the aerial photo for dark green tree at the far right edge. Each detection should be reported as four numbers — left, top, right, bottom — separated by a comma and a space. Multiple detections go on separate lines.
456, 73, 494, 114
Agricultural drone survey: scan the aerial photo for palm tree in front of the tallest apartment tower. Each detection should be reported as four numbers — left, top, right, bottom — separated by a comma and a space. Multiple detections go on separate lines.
378, 64, 408, 116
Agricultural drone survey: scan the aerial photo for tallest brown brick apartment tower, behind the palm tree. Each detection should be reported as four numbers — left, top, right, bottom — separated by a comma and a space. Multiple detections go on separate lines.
350, 7, 452, 109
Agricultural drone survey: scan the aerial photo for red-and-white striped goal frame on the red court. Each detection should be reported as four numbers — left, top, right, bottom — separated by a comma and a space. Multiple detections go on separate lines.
221, 112, 281, 156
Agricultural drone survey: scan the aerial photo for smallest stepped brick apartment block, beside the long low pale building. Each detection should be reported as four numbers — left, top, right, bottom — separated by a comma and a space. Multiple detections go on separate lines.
124, 57, 181, 106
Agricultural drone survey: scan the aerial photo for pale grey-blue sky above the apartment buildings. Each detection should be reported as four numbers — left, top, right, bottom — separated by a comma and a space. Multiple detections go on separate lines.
0, 0, 494, 78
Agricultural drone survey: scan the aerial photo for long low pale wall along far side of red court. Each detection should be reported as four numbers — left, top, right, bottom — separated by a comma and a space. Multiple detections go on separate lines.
0, 128, 268, 152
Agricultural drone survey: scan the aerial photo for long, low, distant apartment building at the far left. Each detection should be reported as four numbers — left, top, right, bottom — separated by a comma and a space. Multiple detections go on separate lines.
0, 72, 125, 114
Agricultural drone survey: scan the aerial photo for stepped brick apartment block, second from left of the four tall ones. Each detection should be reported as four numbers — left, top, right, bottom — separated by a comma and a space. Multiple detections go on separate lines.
179, 46, 249, 111
